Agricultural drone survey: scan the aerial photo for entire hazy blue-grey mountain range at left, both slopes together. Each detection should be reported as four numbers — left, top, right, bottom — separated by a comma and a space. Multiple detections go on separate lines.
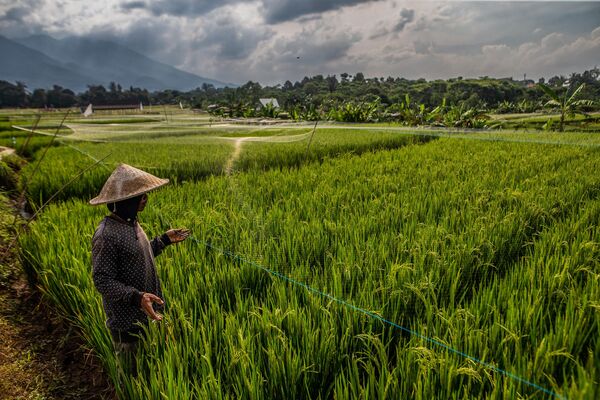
0, 35, 235, 92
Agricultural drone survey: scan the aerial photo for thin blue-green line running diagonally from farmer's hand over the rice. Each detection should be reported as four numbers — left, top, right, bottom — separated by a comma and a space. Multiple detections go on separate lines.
190, 236, 566, 399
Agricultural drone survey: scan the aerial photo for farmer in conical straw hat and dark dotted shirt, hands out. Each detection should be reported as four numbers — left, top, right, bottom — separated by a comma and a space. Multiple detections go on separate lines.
90, 164, 189, 375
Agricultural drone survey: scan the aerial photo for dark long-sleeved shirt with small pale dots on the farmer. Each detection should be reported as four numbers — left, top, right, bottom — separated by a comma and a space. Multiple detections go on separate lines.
92, 215, 170, 341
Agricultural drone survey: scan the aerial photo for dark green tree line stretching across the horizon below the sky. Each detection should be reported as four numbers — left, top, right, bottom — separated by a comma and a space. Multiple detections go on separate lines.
0, 68, 600, 116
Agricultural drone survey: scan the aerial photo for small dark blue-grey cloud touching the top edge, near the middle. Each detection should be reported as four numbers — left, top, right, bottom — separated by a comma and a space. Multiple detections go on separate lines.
262, 0, 379, 24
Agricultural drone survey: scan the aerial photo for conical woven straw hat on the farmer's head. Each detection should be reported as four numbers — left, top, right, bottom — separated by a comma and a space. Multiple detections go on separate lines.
90, 164, 169, 206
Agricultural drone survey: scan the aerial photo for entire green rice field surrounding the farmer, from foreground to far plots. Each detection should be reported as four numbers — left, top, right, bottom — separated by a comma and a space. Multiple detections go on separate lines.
11, 108, 600, 399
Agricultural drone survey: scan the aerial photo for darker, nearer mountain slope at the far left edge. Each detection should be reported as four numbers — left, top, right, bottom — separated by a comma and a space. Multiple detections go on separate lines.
0, 36, 95, 90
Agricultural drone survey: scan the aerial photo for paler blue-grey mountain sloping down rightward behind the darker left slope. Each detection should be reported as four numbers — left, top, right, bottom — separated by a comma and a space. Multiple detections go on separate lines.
0, 35, 235, 91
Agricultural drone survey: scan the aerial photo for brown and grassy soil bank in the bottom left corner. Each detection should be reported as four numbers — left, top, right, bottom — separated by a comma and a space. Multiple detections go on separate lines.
0, 193, 116, 400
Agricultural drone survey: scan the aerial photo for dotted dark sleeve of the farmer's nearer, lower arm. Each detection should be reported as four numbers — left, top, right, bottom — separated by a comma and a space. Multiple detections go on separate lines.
92, 234, 143, 307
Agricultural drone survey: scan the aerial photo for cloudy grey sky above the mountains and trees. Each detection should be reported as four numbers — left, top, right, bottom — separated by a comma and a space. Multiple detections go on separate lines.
0, 0, 600, 84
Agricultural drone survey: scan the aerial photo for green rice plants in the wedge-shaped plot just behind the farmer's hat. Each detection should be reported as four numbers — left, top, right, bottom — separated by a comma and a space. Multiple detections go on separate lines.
24, 129, 432, 204
